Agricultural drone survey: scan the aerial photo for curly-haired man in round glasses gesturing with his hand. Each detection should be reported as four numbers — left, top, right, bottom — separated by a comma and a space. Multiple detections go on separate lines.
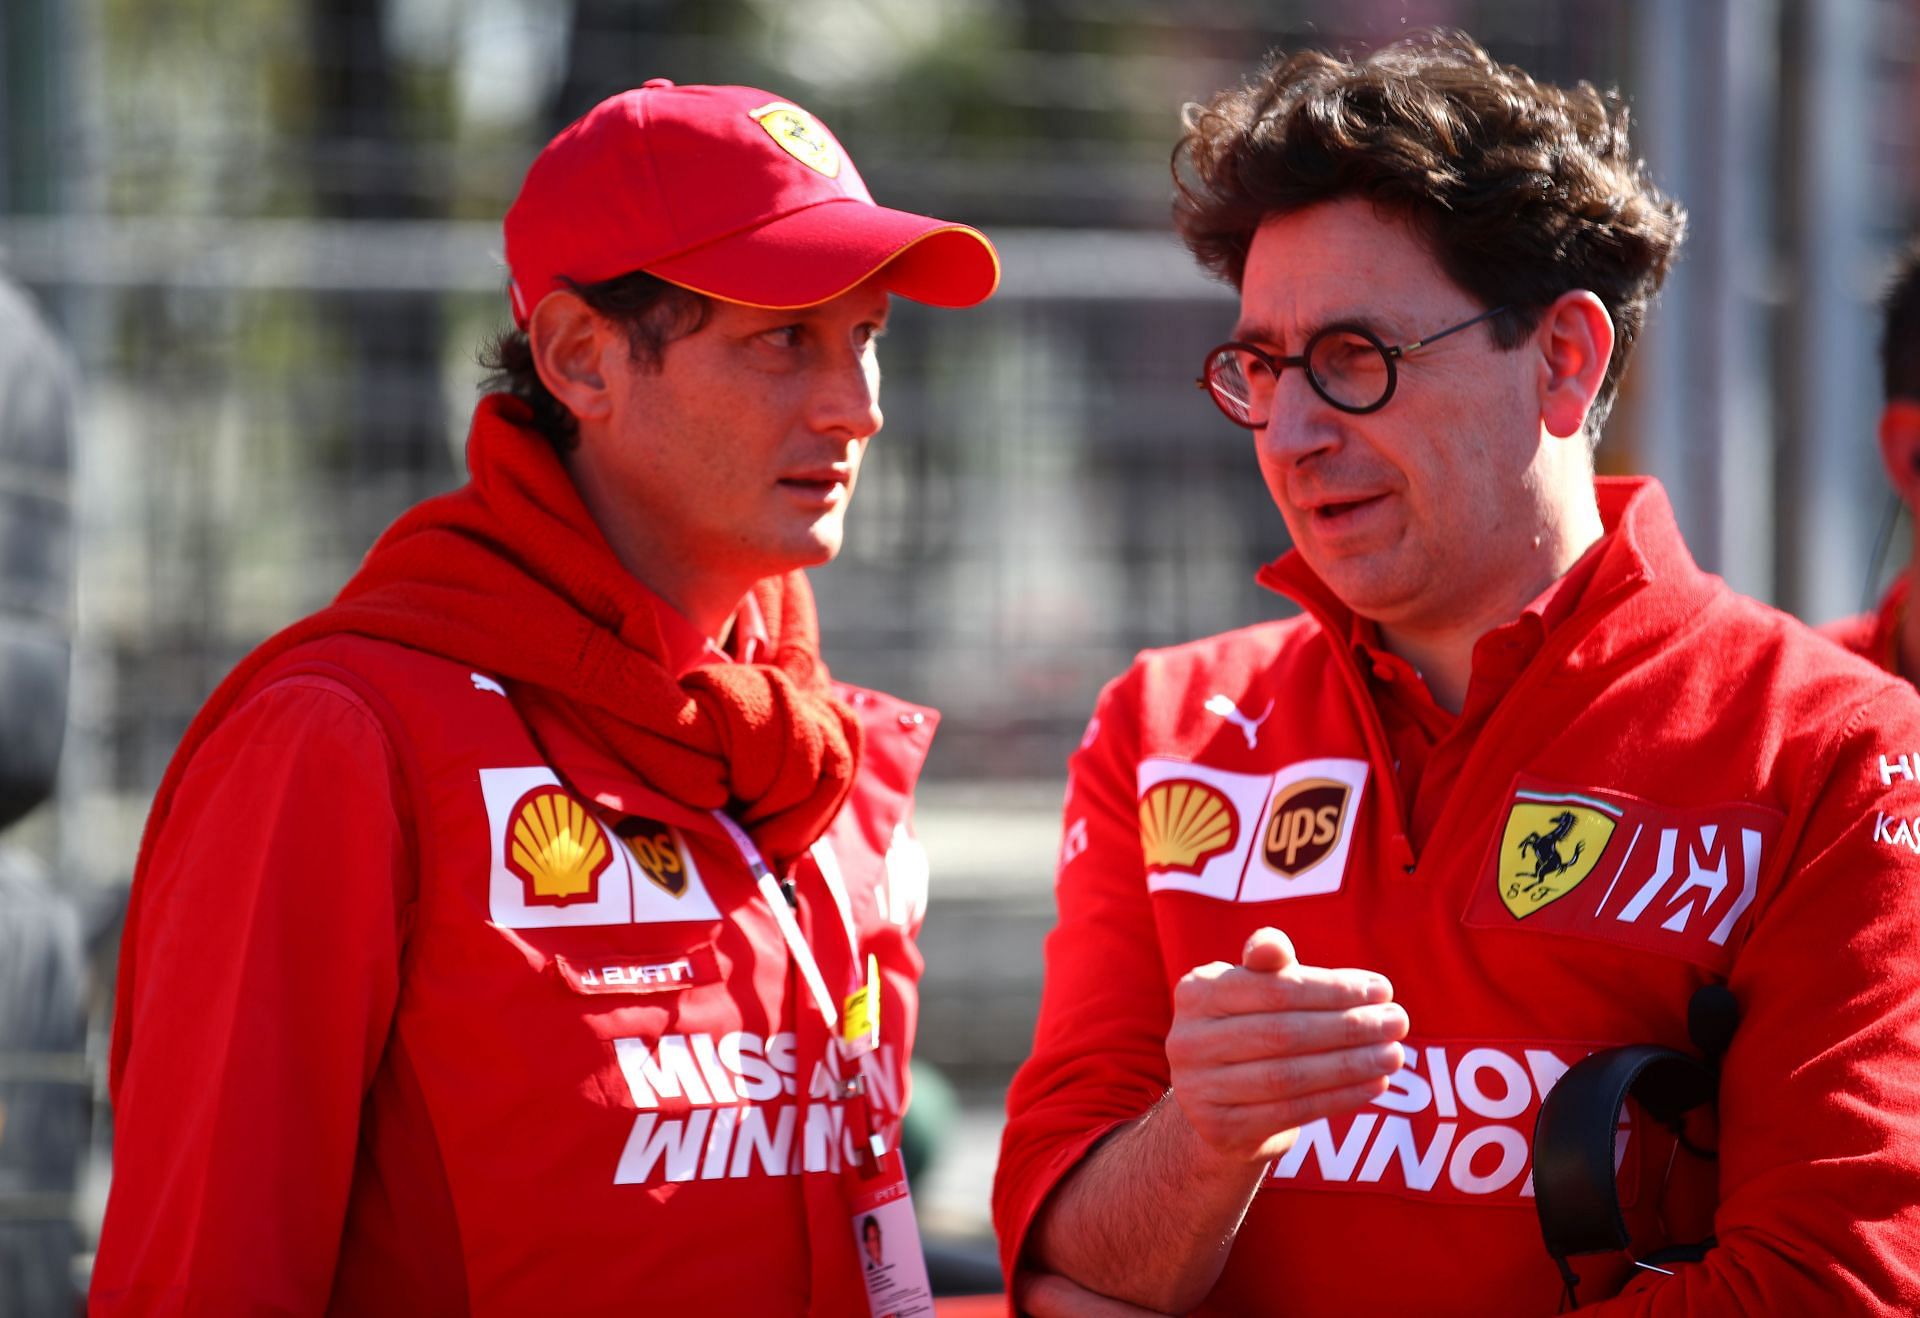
995, 37, 1920, 1316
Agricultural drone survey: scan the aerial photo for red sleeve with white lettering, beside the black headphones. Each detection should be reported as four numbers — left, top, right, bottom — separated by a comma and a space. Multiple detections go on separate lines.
1582, 688, 1920, 1316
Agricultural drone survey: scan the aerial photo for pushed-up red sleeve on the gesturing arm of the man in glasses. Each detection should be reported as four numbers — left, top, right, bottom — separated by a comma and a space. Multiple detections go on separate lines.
993, 678, 1173, 1278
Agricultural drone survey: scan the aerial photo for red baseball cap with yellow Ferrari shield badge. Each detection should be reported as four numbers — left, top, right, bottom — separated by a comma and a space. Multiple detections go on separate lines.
507, 79, 1000, 329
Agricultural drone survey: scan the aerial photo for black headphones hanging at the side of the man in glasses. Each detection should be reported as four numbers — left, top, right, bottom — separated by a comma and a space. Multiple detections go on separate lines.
1534, 984, 1740, 1310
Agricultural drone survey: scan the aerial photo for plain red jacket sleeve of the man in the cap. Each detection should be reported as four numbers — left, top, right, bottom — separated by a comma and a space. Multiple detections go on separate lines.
90, 676, 413, 1314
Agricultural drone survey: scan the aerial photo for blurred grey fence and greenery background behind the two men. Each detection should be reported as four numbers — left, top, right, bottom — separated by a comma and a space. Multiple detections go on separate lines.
0, 0, 1920, 1312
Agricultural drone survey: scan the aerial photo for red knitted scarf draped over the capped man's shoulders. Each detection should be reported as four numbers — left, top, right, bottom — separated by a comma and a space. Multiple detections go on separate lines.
140, 394, 860, 872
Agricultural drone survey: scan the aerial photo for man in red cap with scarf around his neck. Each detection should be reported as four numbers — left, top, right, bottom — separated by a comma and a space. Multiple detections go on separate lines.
92, 81, 998, 1314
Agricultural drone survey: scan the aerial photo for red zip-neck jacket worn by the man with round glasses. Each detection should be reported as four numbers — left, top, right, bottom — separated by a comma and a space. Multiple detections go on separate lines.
995, 480, 1920, 1316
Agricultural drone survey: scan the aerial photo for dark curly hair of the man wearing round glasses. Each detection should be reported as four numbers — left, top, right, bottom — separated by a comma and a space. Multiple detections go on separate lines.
1173, 33, 1686, 436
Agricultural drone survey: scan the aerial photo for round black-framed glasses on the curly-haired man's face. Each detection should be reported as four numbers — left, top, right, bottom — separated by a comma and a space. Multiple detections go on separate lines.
1194, 305, 1507, 430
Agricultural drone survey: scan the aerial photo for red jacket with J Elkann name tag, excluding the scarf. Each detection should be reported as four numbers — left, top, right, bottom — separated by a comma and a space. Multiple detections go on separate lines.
92, 636, 935, 1314
